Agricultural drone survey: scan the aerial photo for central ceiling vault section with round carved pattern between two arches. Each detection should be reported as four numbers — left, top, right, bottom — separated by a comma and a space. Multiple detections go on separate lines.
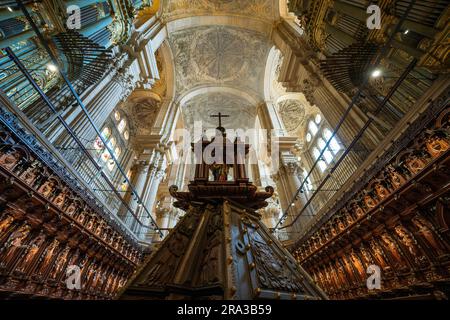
170, 26, 270, 93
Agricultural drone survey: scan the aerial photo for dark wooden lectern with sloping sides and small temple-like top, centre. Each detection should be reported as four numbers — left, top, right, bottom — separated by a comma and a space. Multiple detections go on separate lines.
121, 125, 326, 300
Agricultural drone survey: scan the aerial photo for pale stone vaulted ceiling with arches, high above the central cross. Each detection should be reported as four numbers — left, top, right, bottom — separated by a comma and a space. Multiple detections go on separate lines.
163, 0, 279, 129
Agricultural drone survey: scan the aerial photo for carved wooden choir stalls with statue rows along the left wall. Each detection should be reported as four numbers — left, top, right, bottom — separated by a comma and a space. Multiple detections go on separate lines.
0, 109, 142, 299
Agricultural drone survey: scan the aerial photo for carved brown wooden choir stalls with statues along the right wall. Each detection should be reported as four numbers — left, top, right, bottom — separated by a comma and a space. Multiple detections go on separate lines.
293, 107, 450, 299
